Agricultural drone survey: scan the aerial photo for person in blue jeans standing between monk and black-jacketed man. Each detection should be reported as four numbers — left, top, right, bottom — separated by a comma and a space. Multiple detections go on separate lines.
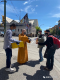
38, 30, 44, 62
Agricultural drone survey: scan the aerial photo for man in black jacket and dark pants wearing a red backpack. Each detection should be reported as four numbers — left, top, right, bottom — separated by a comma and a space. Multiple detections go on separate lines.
36, 30, 55, 71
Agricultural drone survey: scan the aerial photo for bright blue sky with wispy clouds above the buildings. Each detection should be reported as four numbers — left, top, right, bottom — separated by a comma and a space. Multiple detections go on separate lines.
0, 0, 60, 32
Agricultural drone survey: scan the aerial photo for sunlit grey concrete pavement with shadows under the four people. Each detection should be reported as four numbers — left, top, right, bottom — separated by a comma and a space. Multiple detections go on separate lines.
0, 37, 60, 80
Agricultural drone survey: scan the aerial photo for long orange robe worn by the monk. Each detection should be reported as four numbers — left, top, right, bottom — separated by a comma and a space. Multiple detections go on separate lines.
17, 34, 30, 64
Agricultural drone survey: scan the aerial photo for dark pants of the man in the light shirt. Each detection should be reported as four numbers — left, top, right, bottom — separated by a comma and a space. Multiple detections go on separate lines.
5, 48, 12, 68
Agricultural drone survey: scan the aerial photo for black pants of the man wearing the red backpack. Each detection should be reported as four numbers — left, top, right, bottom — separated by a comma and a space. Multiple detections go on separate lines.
46, 48, 55, 69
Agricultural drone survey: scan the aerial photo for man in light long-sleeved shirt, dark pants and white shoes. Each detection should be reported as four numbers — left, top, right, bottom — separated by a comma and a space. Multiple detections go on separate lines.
3, 23, 20, 72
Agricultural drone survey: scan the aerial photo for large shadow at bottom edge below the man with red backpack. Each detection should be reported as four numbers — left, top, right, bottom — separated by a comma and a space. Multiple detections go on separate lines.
23, 66, 53, 80
